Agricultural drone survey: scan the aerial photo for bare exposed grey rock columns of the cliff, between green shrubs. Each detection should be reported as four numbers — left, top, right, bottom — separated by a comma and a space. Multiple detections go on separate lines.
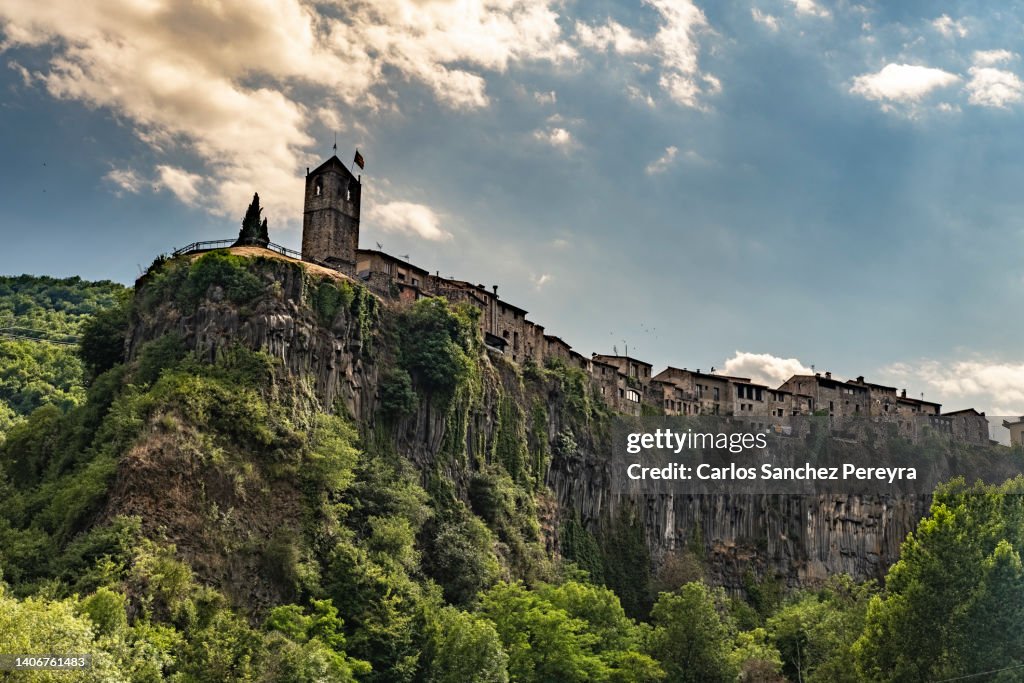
127, 253, 930, 592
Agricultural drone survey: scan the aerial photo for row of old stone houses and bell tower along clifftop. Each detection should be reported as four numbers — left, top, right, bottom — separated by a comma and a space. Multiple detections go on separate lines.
240, 156, 989, 444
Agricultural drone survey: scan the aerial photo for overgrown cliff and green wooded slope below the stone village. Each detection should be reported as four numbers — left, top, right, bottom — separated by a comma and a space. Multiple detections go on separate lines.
0, 249, 1024, 682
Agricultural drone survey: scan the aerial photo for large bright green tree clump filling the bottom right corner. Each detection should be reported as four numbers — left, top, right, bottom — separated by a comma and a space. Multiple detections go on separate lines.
853, 477, 1024, 681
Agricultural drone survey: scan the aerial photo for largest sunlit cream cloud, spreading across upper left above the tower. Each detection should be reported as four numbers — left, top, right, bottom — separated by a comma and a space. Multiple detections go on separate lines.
0, 0, 575, 224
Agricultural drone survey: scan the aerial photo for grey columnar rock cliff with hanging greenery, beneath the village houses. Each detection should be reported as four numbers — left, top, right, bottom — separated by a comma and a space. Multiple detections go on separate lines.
128, 249, 929, 592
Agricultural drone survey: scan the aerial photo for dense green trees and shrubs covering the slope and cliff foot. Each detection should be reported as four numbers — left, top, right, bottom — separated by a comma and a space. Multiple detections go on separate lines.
0, 264, 1024, 683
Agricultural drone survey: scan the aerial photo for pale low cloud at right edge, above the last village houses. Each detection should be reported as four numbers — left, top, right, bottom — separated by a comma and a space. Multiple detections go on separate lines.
881, 357, 1024, 416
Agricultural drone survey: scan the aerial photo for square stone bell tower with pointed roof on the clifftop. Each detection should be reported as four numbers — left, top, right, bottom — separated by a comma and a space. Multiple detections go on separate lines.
302, 156, 361, 274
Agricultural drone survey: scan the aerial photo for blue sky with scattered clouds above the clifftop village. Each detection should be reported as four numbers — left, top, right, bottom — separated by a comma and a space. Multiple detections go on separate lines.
0, 0, 1024, 415
